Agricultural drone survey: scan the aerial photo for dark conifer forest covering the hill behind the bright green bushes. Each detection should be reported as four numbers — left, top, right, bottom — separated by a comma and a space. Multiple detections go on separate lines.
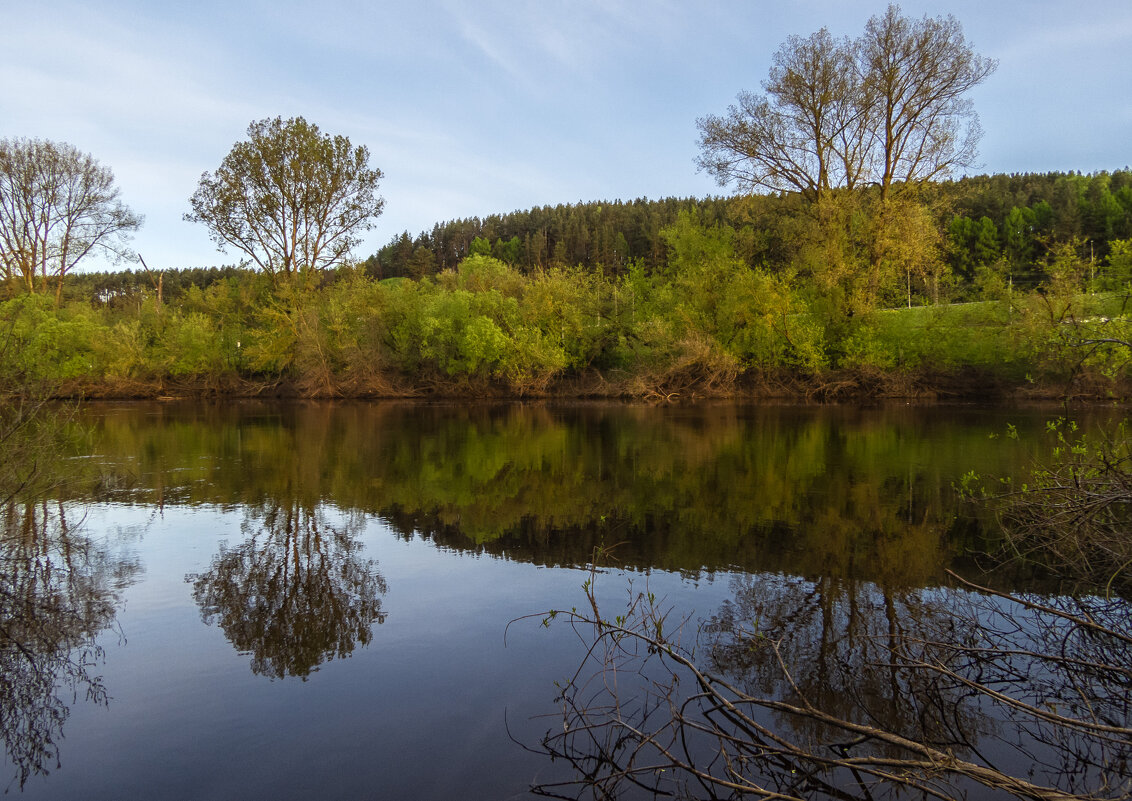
363, 170, 1132, 284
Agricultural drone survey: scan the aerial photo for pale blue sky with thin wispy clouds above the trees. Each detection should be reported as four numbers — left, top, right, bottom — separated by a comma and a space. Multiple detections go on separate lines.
0, 0, 1132, 269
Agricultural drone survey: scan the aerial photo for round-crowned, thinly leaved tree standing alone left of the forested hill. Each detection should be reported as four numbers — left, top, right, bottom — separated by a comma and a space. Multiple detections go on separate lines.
185, 117, 385, 285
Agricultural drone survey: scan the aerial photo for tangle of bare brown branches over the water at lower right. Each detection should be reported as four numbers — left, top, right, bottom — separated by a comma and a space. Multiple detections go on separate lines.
520, 563, 1132, 801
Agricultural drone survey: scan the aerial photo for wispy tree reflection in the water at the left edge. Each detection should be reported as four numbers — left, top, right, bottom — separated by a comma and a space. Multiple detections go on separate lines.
0, 502, 140, 787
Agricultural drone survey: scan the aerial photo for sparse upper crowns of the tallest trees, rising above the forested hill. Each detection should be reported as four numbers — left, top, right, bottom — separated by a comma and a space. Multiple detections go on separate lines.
696, 6, 997, 200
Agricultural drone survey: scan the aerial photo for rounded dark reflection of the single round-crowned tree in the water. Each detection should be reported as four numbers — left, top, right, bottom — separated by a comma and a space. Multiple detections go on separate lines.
188, 500, 386, 679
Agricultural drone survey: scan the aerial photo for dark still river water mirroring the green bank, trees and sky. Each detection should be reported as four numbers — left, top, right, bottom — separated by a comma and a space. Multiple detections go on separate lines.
0, 403, 1122, 800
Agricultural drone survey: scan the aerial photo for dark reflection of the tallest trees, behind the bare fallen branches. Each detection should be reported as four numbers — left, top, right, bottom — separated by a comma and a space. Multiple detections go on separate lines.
704, 575, 994, 758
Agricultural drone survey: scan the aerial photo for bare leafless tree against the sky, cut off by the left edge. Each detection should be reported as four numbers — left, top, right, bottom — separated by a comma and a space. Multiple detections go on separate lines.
0, 139, 142, 302
